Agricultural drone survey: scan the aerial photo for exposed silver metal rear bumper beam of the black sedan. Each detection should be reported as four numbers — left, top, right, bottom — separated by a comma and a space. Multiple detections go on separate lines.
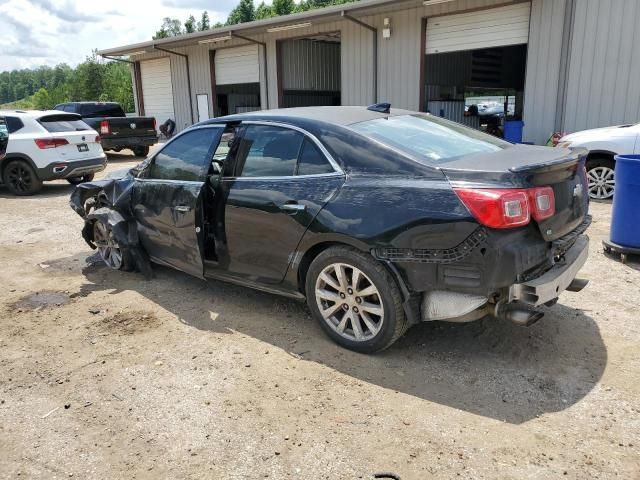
509, 235, 589, 306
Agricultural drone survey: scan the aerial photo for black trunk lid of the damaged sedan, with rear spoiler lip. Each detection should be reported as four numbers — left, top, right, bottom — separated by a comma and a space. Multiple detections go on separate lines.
439, 145, 589, 241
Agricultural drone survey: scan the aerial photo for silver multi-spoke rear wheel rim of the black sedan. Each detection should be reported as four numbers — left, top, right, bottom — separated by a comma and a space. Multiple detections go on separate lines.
315, 263, 384, 342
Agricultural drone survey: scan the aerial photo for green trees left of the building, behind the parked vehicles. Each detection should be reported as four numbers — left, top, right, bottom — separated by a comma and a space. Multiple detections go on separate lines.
0, 52, 135, 112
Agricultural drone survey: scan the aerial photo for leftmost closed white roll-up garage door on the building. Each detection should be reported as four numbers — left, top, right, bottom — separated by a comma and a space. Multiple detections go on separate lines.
140, 58, 176, 125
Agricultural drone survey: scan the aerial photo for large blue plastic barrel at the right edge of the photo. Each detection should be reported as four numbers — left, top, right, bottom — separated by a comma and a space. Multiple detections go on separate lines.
611, 155, 640, 248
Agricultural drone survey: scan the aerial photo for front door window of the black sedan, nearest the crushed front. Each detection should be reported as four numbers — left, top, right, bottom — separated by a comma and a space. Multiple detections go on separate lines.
144, 128, 220, 182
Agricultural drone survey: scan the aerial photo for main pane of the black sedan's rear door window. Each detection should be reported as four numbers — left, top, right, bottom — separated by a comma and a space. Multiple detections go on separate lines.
234, 125, 304, 177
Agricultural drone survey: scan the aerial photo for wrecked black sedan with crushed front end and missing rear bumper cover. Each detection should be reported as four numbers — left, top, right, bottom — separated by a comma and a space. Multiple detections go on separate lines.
71, 104, 590, 352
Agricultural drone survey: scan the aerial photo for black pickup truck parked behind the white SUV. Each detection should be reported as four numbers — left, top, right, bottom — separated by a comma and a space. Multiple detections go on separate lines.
54, 102, 158, 157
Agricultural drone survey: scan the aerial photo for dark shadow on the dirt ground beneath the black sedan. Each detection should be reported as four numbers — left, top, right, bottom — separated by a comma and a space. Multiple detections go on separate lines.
48, 254, 607, 424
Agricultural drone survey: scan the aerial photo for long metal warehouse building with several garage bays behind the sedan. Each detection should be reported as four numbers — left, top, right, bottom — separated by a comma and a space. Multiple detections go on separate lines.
99, 0, 640, 144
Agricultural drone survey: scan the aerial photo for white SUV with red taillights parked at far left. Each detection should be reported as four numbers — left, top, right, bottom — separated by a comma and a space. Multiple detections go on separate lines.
0, 110, 107, 195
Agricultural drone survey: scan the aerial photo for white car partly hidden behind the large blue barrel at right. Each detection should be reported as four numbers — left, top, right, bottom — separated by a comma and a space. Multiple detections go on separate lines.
557, 123, 640, 200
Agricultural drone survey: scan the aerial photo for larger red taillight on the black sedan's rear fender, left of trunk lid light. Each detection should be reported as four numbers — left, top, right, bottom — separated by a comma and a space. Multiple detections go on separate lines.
455, 188, 531, 228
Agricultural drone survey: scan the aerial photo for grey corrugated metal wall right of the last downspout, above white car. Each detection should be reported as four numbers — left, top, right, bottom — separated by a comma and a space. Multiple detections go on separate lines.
563, 0, 640, 132
